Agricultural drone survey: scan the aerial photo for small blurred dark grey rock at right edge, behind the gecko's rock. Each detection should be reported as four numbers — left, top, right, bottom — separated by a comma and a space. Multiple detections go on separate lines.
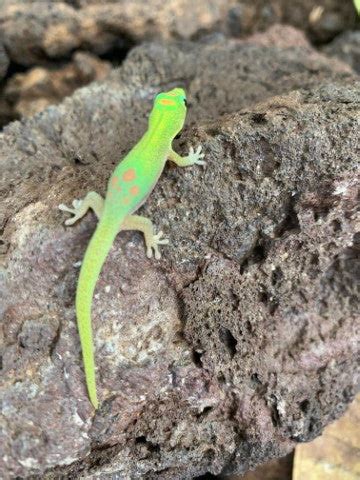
323, 31, 360, 73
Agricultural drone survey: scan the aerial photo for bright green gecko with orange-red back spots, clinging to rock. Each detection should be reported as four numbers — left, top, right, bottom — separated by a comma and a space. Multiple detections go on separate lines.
59, 88, 205, 409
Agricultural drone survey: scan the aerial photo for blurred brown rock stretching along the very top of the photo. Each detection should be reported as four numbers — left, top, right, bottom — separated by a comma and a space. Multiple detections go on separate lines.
0, 0, 356, 65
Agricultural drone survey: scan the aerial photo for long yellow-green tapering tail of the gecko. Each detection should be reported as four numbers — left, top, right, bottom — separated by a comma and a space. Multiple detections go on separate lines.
75, 217, 119, 409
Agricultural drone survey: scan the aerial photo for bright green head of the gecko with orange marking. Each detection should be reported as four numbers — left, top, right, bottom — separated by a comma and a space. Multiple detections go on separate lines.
149, 88, 186, 137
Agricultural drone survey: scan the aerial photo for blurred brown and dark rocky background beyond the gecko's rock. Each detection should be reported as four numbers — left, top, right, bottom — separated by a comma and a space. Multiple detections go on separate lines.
0, 0, 360, 131
